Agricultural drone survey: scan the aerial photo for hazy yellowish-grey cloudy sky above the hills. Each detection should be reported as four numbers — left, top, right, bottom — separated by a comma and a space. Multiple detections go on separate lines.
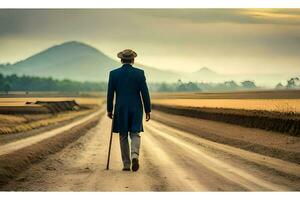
0, 9, 300, 74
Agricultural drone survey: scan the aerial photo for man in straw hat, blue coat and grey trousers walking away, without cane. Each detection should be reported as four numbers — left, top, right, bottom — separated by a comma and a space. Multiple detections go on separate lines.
107, 49, 151, 171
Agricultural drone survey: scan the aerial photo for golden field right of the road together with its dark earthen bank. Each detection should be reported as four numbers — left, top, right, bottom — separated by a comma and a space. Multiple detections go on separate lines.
152, 91, 300, 136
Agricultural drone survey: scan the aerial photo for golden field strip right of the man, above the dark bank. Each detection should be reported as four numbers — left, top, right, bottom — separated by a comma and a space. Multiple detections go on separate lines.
152, 90, 300, 113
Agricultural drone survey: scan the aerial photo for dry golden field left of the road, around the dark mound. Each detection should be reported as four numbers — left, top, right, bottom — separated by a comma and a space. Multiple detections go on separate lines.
0, 98, 103, 134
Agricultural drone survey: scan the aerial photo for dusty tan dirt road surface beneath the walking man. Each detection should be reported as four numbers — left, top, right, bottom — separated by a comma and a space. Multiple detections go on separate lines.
1, 112, 300, 191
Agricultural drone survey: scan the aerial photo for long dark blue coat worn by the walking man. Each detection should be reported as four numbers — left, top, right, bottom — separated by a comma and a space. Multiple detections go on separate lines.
107, 64, 151, 134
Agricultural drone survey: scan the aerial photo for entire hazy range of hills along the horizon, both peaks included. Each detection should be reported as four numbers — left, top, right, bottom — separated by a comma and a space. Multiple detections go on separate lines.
0, 41, 295, 87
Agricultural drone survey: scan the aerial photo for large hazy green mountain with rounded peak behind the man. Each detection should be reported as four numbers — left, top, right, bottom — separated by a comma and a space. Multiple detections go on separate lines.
0, 41, 180, 82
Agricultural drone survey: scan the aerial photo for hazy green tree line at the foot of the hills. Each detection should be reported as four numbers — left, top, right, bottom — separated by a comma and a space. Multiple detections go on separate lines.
0, 73, 300, 93
